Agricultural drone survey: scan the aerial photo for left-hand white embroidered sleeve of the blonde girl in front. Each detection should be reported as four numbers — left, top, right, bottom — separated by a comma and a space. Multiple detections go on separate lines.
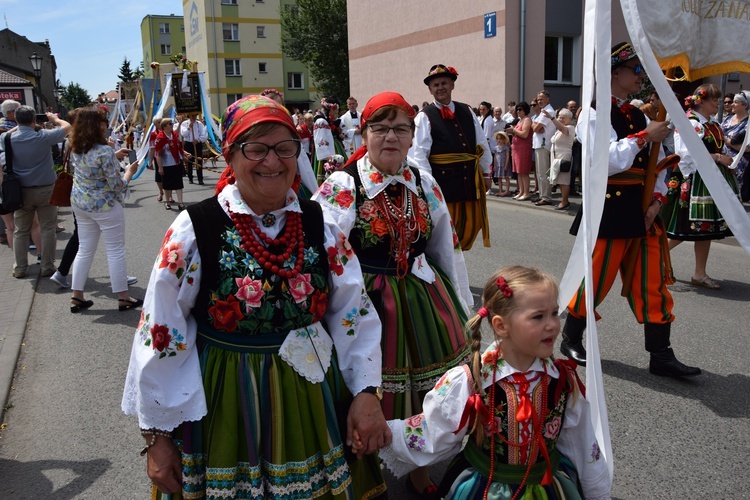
379, 366, 473, 477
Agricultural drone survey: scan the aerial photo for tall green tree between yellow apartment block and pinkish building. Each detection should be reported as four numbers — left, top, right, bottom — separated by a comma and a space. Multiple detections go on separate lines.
280, 0, 349, 101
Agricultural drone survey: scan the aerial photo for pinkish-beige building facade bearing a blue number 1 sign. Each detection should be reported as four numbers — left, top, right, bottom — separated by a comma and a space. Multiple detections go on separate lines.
347, 0, 750, 113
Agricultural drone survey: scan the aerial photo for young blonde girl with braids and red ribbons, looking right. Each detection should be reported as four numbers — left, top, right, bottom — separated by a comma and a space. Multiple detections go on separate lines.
376, 266, 611, 499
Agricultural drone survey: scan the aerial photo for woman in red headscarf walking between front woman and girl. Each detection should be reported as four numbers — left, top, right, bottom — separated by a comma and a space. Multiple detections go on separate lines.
313, 92, 473, 494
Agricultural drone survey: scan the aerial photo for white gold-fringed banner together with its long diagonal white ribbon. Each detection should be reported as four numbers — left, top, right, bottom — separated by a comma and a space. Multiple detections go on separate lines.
620, 0, 750, 254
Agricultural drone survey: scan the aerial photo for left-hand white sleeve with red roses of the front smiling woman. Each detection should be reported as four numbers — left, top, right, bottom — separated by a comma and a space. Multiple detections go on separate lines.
122, 212, 206, 430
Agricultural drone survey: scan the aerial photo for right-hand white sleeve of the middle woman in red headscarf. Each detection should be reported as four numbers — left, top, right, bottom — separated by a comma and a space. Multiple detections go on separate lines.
420, 168, 474, 313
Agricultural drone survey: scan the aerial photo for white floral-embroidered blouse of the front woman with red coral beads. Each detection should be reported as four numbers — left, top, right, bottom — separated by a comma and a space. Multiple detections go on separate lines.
122, 184, 382, 430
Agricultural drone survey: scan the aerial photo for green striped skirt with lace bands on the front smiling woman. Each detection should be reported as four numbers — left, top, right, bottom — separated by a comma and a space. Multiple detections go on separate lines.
154, 336, 385, 499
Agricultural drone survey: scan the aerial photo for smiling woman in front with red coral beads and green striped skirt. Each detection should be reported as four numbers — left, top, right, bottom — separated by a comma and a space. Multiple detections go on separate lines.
122, 96, 390, 499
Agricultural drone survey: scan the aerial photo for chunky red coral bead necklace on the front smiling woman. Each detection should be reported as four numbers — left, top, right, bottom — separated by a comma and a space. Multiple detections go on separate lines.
227, 204, 305, 278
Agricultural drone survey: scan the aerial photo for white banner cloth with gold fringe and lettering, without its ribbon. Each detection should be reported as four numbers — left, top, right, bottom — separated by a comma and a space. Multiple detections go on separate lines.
622, 0, 750, 80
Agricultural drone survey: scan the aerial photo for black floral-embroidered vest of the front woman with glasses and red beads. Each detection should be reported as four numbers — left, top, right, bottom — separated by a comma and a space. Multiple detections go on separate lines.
188, 197, 328, 335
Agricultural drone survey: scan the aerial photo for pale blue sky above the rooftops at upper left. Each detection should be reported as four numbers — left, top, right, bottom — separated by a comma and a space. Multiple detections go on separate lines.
0, 0, 182, 98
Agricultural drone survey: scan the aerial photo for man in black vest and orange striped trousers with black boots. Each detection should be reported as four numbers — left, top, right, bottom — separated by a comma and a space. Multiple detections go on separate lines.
560, 42, 701, 377
